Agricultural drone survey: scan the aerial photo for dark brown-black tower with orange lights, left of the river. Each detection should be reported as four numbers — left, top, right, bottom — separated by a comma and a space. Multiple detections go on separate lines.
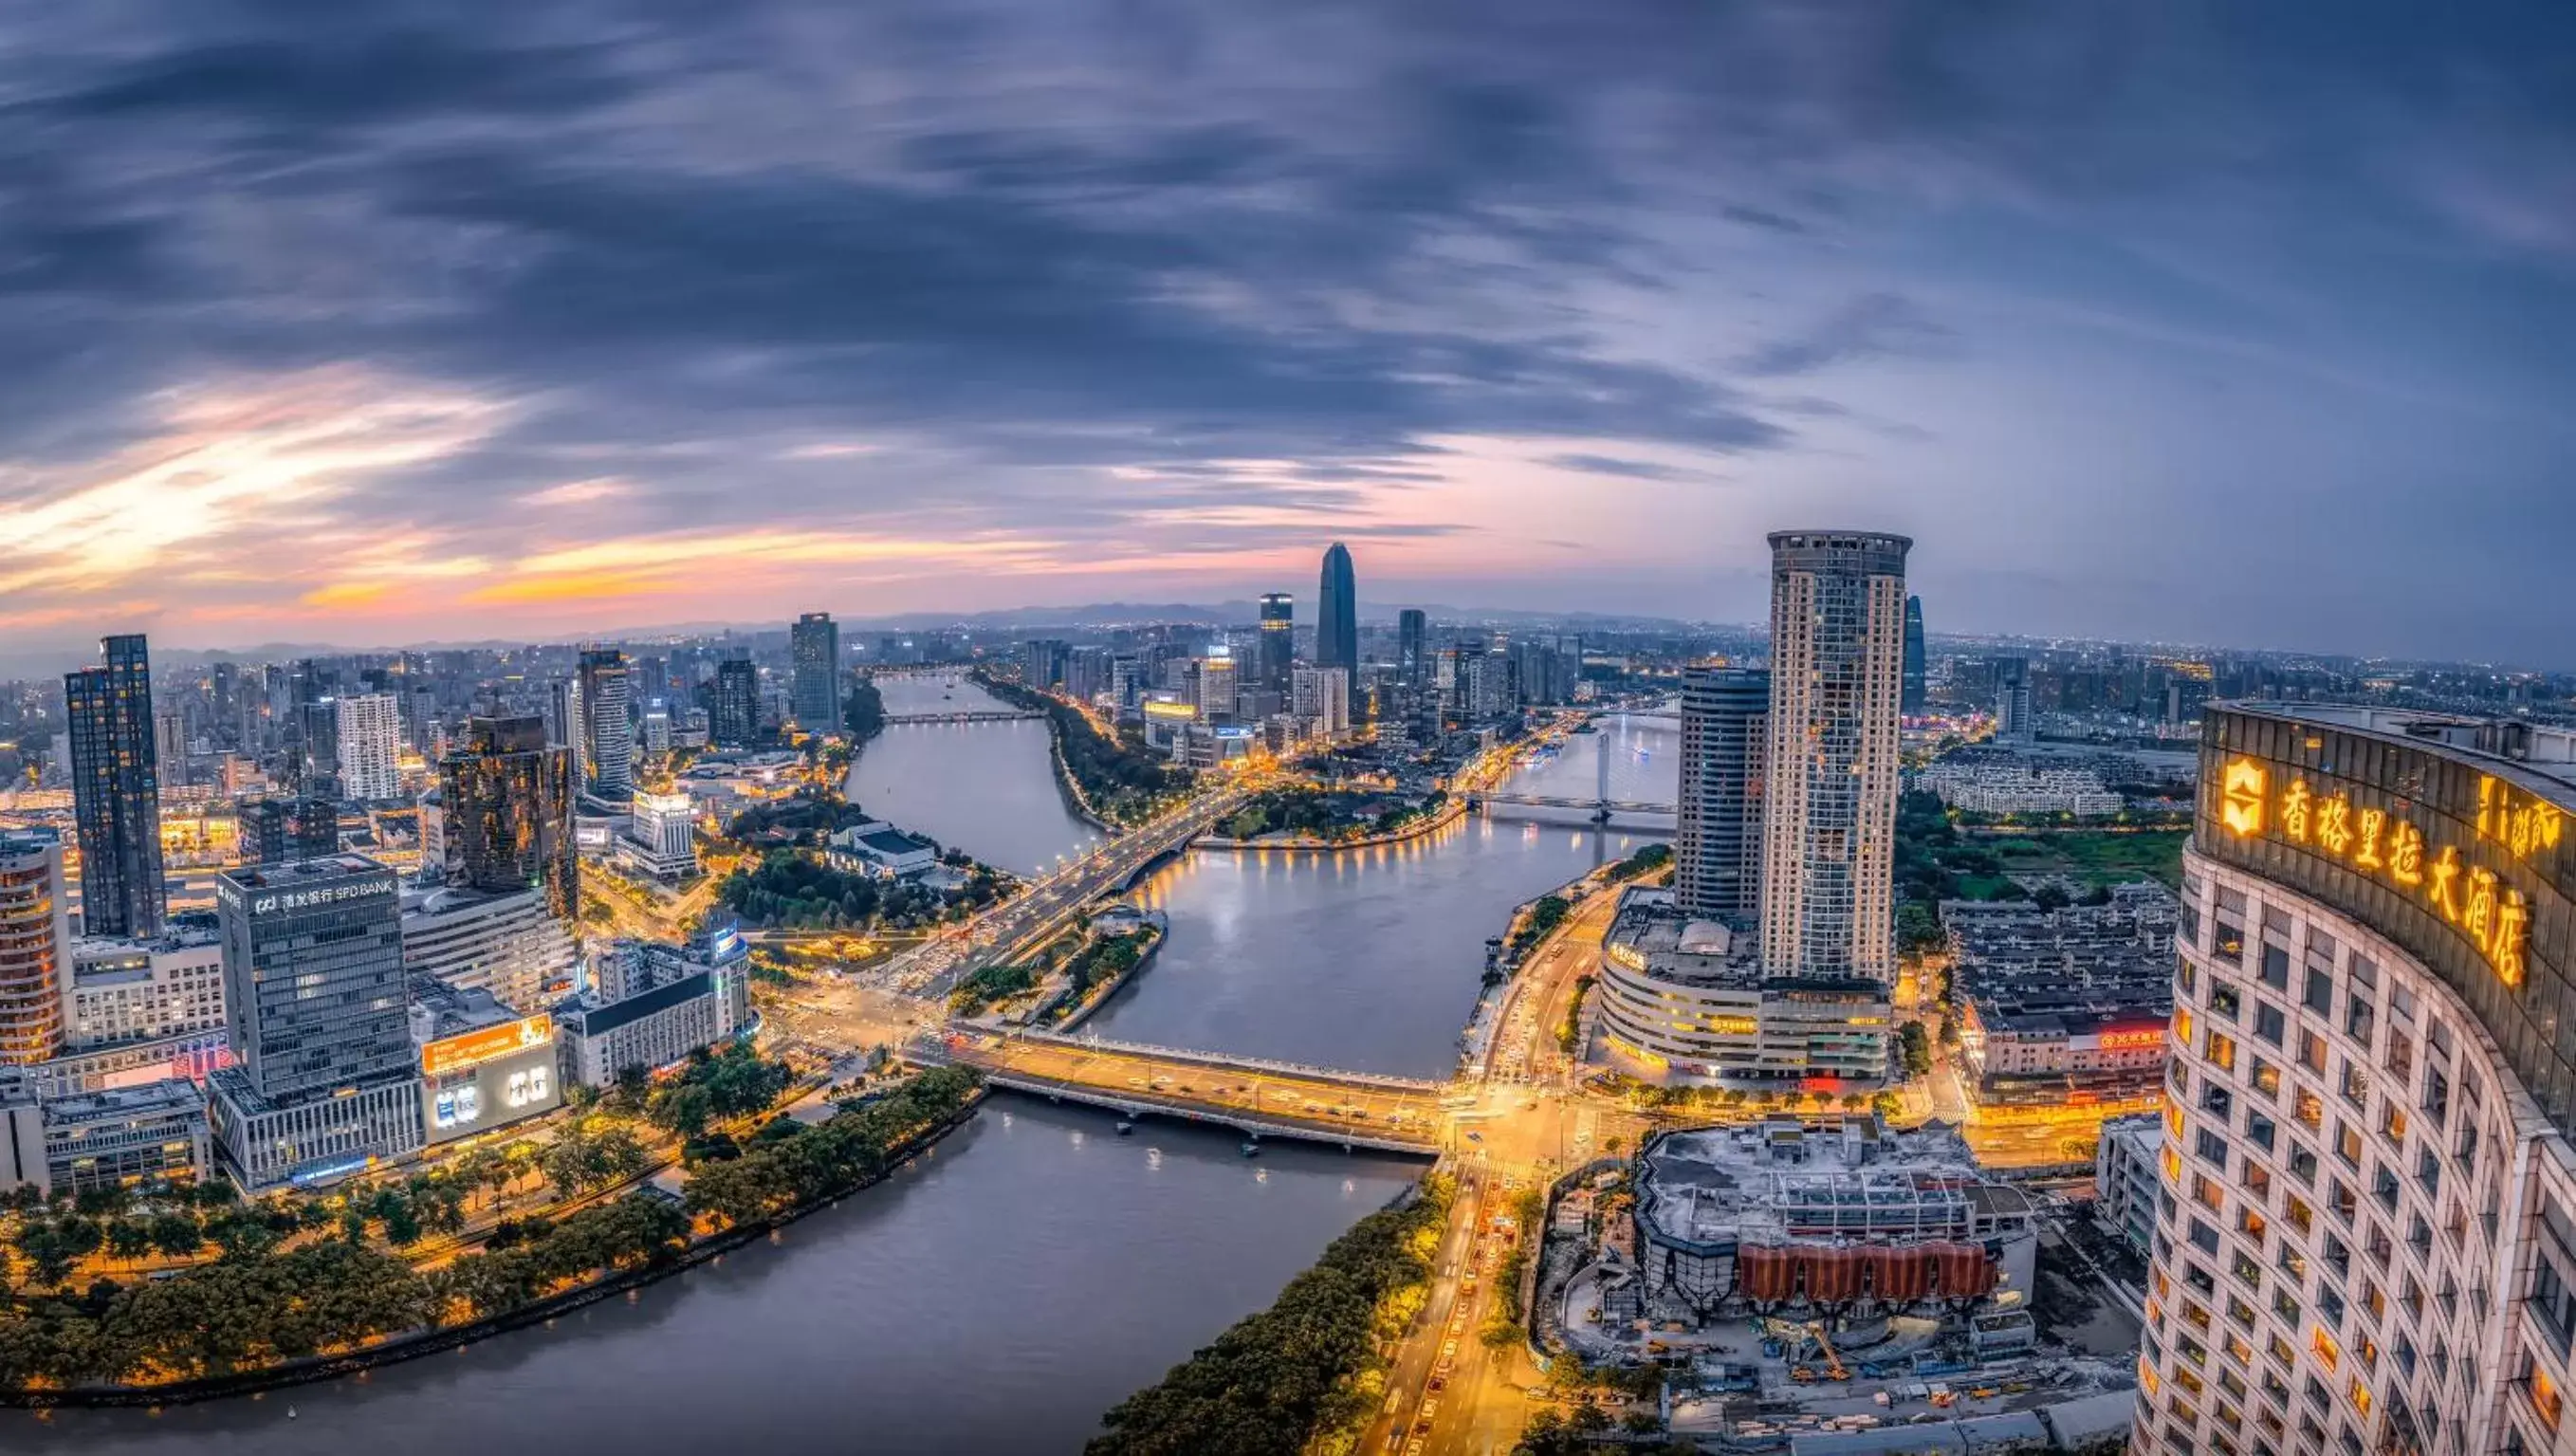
438, 716, 582, 923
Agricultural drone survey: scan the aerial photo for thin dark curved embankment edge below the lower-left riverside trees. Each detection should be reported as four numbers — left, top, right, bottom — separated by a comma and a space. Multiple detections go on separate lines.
0, 1085, 989, 1412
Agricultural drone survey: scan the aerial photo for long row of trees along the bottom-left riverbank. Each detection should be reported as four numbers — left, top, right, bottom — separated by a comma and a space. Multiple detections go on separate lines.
0, 1196, 688, 1389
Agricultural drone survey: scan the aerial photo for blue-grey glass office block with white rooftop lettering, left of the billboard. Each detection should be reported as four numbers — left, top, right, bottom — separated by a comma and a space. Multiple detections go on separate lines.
209, 856, 422, 1190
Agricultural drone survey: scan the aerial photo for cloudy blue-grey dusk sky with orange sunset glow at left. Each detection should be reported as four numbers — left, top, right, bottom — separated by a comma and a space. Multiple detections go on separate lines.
0, 0, 2576, 668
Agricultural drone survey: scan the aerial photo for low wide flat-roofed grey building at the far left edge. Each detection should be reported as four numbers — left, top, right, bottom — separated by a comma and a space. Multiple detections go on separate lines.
0, 1072, 212, 1196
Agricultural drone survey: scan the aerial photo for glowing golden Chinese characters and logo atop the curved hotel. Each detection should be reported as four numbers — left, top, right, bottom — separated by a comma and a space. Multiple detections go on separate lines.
2217, 755, 2566, 987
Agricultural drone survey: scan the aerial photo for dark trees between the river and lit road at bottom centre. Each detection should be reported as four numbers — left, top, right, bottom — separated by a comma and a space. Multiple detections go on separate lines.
1084, 1178, 1450, 1456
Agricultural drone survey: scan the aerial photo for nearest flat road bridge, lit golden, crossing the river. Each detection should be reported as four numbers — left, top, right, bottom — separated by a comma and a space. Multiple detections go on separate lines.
920, 1025, 1474, 1157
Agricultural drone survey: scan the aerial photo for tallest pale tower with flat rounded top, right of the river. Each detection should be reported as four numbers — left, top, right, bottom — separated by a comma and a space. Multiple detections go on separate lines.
1762, 531, 1914, 979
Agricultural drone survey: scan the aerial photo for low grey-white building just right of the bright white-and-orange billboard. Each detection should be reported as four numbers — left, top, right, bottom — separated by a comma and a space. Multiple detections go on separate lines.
554, 941, 752, 1087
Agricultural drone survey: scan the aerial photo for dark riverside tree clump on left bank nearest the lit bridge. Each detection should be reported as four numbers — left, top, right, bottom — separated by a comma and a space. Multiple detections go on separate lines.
688, 1067, 982, 1224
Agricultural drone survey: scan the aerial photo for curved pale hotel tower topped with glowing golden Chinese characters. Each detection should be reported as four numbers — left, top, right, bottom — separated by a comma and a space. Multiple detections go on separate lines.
2130, 704, 2576, 1456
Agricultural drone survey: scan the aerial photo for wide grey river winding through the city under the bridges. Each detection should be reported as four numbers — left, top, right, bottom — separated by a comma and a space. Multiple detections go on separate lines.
45, 680, 1674, 1456
